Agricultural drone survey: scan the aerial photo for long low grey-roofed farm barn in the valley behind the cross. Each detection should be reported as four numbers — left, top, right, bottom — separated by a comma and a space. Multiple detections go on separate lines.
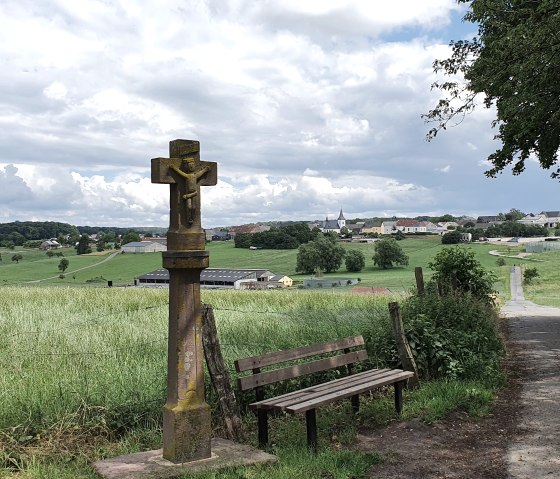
137, 268, 280, 289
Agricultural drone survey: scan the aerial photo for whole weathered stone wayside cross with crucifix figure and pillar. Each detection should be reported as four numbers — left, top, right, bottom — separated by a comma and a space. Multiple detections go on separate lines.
152, 140, 218, 463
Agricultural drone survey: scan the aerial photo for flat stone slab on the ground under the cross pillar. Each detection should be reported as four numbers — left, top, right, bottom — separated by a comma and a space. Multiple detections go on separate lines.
94, 438, 278, 479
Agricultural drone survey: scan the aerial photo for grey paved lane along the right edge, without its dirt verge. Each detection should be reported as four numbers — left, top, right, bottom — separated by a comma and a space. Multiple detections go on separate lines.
502, 266, 560, 479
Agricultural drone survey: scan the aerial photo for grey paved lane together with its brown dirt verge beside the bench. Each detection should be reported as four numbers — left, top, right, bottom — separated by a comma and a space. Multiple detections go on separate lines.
357, 267, 560, 479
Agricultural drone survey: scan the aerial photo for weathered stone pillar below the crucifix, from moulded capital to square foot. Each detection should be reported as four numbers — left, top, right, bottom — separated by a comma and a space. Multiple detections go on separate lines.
163, 250, 211, 463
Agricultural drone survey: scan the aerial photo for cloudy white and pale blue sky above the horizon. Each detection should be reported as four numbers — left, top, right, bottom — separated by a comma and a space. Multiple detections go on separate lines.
0, 0, 560, 227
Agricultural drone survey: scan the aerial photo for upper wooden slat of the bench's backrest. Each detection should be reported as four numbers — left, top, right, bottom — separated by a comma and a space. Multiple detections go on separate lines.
235, 336, 365, 373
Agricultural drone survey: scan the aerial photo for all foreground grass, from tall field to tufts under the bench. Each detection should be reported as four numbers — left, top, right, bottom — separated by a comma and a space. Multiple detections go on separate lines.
0, 287, 504, 479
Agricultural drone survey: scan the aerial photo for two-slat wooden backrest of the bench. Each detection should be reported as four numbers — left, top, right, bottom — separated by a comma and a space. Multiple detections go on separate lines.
235, 336, 368, 391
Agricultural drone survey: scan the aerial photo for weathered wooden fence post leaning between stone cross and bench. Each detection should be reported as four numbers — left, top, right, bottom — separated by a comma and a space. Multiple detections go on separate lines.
201, 304, 244, 442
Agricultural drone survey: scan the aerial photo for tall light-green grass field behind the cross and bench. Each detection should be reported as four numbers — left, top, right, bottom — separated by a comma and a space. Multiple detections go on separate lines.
0, 287, 396, 429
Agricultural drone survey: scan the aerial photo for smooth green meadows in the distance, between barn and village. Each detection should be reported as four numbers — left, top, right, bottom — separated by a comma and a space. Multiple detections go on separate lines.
0, 236, 531, 296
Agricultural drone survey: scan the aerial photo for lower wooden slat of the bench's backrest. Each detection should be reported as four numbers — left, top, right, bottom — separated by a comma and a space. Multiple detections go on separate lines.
237, 349, 368, 391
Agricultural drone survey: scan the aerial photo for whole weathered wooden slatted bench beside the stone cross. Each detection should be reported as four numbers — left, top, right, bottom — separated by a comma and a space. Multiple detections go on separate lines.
235, 336, 413, 451
